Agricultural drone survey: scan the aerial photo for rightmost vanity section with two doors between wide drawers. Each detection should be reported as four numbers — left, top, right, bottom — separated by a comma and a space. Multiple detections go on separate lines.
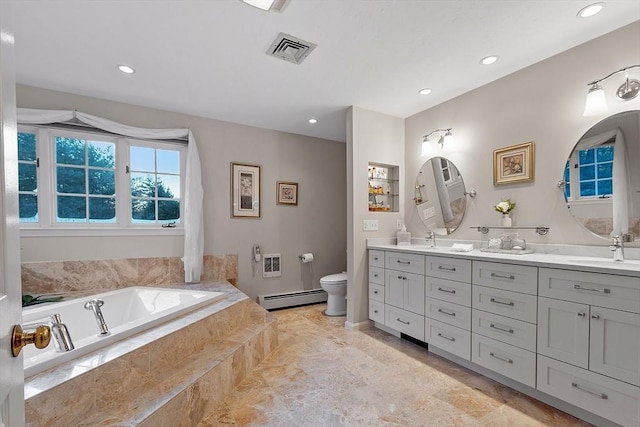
537, 268, 640, 426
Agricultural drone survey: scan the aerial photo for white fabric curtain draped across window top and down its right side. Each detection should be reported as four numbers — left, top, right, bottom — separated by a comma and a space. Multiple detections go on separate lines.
17, 108, 204, 283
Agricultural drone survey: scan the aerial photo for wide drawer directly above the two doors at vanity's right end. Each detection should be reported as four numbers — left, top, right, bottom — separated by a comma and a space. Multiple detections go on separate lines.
539, 268, 640, 313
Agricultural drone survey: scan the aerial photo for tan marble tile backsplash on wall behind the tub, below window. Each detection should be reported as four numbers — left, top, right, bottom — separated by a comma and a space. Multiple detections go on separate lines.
22, 254, 238, 295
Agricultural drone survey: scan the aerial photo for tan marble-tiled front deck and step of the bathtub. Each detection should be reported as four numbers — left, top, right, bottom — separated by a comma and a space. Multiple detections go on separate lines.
25, 282, 277, 427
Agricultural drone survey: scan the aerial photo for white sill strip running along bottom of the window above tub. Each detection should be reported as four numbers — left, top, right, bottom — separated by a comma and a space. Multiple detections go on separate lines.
20, 226, 184, 237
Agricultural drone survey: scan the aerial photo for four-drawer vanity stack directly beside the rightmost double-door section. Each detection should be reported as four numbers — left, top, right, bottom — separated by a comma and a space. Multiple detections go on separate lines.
471, 261, 538, 387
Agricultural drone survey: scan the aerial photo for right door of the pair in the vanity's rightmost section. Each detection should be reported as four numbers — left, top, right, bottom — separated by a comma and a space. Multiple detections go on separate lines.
589, 307, 640, 386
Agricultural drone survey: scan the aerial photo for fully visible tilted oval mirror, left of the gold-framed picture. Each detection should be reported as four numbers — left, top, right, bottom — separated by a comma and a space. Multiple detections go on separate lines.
413, 157, 467, 235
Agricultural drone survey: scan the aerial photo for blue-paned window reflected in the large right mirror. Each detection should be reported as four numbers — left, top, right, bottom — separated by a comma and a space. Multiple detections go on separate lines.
564, 145, 614, 200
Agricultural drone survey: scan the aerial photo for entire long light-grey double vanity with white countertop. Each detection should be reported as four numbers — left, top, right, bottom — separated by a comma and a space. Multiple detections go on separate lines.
368, 243, 640, 427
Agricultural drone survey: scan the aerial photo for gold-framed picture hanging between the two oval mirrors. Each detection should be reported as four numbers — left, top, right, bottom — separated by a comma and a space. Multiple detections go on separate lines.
493, 142, 535, 185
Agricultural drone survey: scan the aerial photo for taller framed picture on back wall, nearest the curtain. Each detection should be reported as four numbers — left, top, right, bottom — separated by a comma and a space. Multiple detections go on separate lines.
231, 163, 260, 218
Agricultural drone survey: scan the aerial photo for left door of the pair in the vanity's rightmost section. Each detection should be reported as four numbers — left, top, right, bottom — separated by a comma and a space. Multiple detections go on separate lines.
538, 297, 589, 369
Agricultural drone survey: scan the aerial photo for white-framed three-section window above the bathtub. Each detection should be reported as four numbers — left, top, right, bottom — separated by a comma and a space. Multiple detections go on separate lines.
18, 126, 186, 234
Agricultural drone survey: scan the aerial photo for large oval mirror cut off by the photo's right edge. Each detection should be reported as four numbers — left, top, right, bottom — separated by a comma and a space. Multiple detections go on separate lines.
562, 110, 640, 244
